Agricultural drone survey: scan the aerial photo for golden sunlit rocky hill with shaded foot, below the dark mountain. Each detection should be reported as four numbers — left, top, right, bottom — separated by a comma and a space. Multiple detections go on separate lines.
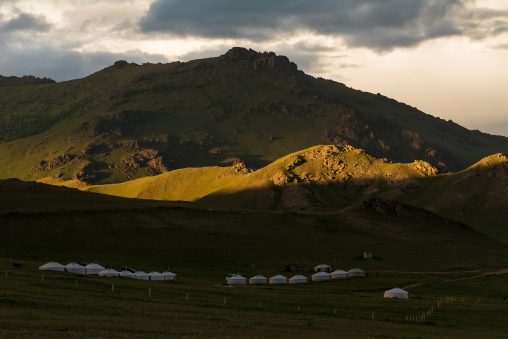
68, 145, 437, 209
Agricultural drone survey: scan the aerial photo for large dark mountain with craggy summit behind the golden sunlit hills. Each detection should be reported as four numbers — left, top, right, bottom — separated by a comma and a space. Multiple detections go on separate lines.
0, 48, 508, 183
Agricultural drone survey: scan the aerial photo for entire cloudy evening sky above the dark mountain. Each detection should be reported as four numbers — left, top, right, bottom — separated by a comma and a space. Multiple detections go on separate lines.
0, 0, 508, 136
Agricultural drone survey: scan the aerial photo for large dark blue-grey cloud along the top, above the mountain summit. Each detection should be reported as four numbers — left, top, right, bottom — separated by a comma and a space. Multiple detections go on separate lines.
139, 0, 508, 50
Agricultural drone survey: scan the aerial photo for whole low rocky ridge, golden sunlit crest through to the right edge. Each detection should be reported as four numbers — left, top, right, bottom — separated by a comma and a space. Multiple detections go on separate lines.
41, 145, 508, 241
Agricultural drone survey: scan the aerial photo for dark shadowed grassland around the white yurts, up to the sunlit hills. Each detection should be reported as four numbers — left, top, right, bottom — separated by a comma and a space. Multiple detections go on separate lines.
0, 182, 508, 338
